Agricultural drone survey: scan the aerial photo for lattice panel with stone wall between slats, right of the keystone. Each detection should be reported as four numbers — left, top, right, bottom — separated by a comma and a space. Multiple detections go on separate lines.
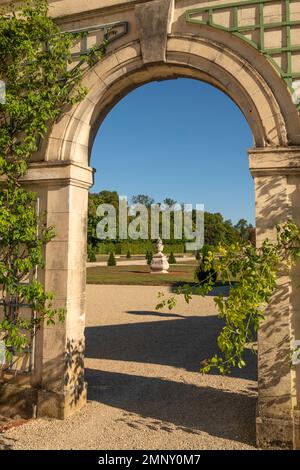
186, 0, 300, 105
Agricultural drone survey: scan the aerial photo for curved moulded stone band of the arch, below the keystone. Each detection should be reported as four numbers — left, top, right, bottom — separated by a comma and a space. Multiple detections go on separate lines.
46, 36, 299, 165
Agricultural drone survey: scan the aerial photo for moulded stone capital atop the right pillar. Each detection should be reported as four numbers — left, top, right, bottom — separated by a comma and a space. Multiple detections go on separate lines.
248, 147, 300, 176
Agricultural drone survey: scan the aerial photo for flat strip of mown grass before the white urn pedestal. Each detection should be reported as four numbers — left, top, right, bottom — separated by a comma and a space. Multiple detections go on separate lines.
87, 264, 195, 286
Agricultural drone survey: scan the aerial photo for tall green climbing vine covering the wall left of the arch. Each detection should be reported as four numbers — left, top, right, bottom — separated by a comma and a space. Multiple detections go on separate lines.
0, 0, 105, 364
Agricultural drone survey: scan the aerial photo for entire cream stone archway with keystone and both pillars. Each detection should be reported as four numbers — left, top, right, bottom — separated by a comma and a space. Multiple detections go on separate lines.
2, 0, 300, 448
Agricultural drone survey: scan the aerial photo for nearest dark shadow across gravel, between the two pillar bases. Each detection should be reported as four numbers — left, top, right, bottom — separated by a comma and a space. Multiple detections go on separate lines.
86, 369, 256, 446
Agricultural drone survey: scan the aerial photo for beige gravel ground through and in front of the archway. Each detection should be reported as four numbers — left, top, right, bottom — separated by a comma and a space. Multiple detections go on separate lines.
0, 285, 256, 450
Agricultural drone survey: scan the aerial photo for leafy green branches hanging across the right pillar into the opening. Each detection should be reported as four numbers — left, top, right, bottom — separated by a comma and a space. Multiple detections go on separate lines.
157, 220, 300, 374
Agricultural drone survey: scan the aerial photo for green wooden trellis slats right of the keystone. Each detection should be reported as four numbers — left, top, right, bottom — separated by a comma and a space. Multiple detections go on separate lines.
186, 0, 300, 105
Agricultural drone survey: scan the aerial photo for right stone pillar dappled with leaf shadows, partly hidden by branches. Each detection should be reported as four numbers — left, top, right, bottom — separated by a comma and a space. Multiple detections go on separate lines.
249, 148, 300, 449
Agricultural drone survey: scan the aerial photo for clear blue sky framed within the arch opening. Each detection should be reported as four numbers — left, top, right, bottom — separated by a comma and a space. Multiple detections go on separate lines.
91, 79, 254, 223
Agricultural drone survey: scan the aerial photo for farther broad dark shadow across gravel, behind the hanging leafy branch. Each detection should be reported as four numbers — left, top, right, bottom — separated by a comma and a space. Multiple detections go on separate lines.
85, 311, 257, 380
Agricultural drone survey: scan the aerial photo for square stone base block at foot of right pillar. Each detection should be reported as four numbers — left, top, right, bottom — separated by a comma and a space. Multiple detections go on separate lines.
256, 416, 294, 450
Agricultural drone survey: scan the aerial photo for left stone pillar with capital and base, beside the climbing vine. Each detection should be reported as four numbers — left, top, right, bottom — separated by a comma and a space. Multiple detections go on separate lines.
0, 162, 93, 419
